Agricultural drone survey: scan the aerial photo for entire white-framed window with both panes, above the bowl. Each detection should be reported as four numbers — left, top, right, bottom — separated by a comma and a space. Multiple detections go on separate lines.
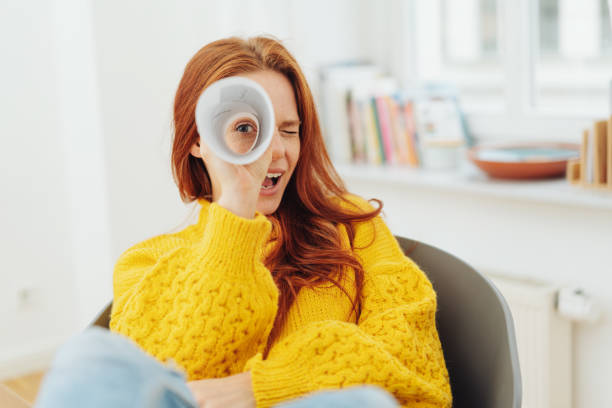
404, 0, 612, 139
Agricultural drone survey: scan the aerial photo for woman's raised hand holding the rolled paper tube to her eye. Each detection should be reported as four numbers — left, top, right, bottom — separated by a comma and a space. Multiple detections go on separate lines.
200, 135, 272, 218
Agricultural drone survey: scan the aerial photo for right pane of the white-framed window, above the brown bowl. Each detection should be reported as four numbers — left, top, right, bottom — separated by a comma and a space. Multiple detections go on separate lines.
533, 0, 612, 115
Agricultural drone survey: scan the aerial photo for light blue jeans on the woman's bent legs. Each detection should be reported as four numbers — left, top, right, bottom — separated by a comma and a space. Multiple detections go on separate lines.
35, 327, 398, 408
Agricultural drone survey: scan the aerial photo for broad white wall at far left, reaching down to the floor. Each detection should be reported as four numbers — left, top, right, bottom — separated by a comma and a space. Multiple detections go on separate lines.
0, 1, 110, 377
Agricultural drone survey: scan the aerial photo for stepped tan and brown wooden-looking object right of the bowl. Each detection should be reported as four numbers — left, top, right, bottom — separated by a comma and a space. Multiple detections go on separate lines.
566, 115, 612, 191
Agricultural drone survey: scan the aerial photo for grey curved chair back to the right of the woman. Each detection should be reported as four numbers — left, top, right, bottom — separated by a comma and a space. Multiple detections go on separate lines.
395, 236, 522, 408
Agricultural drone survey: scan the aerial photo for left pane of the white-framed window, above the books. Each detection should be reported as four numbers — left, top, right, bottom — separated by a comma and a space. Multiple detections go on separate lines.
414, 0, 504, 110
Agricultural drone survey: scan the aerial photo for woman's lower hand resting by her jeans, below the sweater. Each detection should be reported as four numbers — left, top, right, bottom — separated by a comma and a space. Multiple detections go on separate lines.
187, 371, 255, 408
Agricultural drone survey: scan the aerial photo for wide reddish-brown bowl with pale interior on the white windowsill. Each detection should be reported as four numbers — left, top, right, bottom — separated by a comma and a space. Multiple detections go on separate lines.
468, 142, 580, 179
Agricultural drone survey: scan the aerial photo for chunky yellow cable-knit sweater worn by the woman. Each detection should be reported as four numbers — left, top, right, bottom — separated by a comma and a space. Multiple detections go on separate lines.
110, 196, 451, 407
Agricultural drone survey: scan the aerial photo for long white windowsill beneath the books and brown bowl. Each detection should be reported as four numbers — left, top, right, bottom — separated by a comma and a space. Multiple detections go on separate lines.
335, 163, 612, 211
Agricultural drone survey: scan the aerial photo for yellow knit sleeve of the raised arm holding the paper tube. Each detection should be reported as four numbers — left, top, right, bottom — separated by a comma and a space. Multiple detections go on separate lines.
110, 203, 278, 380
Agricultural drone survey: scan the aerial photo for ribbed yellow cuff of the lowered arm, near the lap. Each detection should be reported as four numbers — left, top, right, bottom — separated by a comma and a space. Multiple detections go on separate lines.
245, 353, 312, 408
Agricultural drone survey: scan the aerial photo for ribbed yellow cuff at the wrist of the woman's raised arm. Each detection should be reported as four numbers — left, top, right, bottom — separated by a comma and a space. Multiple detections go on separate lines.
198, 203, 272, 271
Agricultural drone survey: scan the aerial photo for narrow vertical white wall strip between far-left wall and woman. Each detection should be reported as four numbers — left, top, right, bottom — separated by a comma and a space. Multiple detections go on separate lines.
54, 0, 113, 334
